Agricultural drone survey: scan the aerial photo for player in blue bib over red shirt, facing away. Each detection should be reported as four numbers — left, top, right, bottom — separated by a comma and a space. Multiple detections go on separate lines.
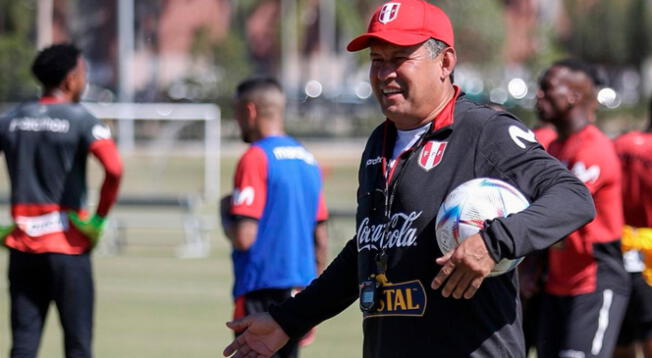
222, 78, 328, 358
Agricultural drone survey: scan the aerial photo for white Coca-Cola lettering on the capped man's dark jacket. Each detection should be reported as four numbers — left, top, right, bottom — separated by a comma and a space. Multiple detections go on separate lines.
357, 211, 423, 251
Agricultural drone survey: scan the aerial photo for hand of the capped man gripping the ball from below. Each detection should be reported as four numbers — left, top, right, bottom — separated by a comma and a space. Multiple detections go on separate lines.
431, 233, 496, 299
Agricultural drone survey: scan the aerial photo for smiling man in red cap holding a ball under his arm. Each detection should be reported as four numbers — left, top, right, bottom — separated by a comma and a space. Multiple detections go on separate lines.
224, 0, 594, 358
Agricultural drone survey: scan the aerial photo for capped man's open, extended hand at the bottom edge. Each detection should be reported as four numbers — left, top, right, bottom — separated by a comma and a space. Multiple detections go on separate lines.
223, 313, 290, 358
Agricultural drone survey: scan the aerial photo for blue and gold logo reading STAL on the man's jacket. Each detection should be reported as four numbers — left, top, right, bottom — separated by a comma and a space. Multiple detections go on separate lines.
364, 280, 427, 318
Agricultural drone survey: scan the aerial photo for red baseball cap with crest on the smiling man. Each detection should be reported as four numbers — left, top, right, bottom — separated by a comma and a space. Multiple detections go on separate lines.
346, 0, 455, 52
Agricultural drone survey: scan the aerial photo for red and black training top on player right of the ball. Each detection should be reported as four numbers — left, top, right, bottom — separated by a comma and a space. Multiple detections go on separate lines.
546, 125, 629, 296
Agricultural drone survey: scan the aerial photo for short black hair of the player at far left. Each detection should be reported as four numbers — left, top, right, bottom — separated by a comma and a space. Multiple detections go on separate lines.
32, 43, 81, 88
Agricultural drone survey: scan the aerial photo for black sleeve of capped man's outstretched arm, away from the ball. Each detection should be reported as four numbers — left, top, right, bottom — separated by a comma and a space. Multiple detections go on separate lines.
269, 238, 358, 338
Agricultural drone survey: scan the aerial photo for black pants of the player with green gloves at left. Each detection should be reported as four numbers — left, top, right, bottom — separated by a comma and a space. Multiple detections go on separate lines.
8, 249, 95, 357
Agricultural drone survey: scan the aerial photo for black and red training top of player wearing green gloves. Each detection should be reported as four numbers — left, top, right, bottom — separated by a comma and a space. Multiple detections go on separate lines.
0, 97, 122, 254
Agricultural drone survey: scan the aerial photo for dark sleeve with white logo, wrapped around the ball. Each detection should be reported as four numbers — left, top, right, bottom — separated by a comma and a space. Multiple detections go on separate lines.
475, 114, 595, 262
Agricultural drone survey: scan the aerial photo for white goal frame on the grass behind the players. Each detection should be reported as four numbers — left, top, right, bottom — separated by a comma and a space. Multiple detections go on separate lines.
82, 102, 221, 258
